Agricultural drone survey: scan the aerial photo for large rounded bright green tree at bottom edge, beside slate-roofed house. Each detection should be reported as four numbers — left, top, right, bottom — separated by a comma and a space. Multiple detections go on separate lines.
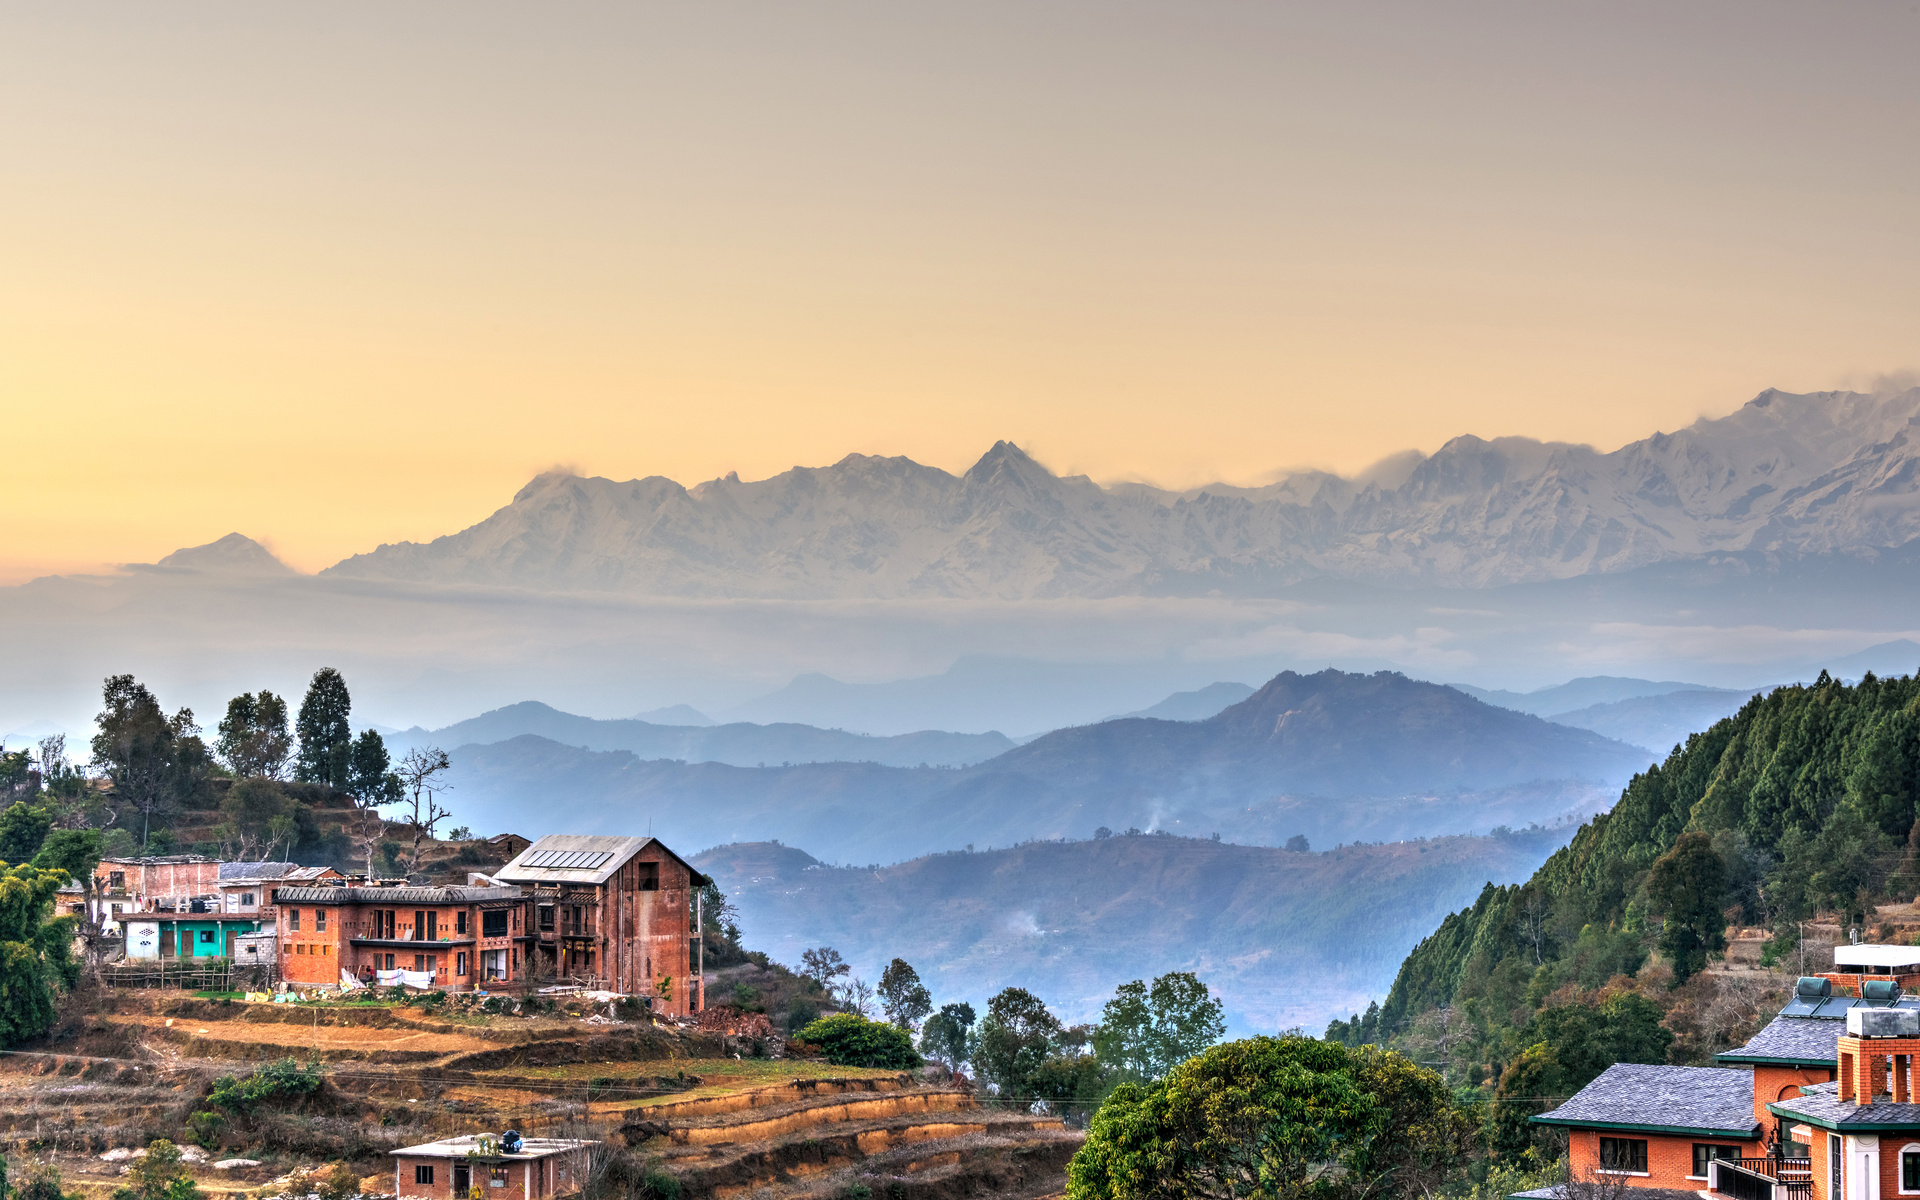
1068, 1037, 1473, 1200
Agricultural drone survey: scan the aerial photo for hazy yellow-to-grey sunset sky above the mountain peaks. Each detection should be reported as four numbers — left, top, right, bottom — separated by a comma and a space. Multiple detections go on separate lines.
11, 0, 1920, 578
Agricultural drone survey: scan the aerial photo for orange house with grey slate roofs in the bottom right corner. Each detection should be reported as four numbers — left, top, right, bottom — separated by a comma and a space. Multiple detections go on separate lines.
1528, 947, 1920, 1200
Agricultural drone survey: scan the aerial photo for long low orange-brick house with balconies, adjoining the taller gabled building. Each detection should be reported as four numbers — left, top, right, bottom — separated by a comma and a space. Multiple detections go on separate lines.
275, 885, 526, 991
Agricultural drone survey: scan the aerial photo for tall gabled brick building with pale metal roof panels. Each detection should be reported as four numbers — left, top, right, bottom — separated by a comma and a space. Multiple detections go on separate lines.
493, 833, 707, 1014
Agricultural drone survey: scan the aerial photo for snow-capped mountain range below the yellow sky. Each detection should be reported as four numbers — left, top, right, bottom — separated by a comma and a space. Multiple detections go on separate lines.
326, 388, 1920, 599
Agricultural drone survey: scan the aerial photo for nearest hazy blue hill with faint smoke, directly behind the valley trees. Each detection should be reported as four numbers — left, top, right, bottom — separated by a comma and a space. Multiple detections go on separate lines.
693, 829, 1567, 1033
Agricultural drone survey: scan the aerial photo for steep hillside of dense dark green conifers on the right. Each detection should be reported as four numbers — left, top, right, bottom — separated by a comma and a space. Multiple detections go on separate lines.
1374, 674, 1920, 1144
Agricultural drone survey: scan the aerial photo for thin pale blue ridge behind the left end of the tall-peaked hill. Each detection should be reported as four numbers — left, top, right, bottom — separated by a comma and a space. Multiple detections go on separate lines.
388, 701, 1014, 766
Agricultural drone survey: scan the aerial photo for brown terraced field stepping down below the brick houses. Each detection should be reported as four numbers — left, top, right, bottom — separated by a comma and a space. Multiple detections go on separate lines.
0, 993, 1081, 1200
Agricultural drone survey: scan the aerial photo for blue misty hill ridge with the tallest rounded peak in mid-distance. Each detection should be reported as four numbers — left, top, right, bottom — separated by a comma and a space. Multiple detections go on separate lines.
439, 670, 1645, 862
